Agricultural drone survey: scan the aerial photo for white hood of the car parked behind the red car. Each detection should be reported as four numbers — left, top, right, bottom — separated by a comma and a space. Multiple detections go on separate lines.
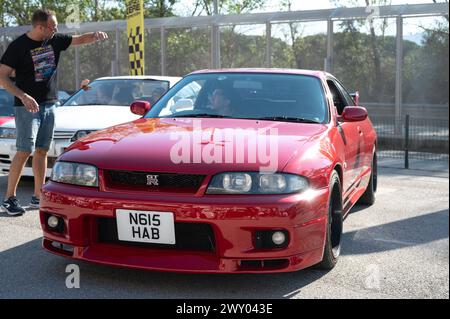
0, 105, 140, 131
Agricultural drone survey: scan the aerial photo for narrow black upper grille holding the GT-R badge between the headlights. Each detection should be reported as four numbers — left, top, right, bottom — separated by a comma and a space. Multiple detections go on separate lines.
104, 170, 205, 193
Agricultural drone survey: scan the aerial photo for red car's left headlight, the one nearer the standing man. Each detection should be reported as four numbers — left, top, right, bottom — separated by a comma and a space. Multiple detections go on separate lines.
50, 162, 98, 187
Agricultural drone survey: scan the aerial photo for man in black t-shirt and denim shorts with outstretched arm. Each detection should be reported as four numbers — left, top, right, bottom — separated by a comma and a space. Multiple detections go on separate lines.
0, 10, 108, 215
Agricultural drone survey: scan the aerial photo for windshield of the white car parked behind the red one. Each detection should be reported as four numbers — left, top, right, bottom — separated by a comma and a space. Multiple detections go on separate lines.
64, 79, 169, 106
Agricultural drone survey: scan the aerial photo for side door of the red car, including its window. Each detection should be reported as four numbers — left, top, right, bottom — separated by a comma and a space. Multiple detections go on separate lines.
327, 78, 364, 196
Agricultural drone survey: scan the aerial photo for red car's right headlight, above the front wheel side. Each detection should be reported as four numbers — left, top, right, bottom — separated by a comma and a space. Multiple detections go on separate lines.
206, 172, 309, 194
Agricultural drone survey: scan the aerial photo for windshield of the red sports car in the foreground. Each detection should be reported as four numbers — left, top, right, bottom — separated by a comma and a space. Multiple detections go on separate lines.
146, 73, 328, 123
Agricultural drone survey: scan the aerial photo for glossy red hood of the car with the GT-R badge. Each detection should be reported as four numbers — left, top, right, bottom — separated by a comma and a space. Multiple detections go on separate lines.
60, 118, 327, 174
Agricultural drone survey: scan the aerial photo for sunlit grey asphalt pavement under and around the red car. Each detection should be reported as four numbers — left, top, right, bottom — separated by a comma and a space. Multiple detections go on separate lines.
0, 161, 449, 299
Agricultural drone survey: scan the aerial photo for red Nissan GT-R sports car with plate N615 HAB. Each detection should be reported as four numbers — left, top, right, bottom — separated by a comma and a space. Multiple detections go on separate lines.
40, 69, 377, 273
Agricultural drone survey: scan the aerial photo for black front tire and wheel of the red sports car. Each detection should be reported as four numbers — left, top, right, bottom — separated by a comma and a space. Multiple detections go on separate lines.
317, 171, 343, 270
